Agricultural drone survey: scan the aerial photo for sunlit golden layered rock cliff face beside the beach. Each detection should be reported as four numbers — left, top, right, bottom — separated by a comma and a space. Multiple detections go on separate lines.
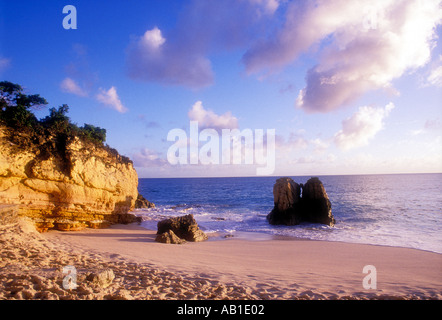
0, 126, 138, 231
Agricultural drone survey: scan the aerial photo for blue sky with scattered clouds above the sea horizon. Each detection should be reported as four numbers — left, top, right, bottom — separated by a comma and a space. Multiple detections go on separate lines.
0, 0, 442, 178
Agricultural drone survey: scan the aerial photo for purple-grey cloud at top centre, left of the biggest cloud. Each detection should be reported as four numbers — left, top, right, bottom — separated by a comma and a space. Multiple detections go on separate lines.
126, 0, 280, 89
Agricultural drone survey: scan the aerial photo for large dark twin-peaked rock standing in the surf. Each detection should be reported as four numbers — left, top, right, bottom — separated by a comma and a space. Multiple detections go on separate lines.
267, 177, 335, 226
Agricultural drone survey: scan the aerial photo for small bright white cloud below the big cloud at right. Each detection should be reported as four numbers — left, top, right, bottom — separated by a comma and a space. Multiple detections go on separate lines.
334, 103, 394, 150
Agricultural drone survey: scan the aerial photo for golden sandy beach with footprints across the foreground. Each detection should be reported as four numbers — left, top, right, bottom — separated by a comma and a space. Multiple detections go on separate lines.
0, 220, 442, 300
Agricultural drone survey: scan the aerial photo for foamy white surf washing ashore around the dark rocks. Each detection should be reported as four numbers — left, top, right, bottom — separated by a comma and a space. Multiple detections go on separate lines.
135, 194, 442, 253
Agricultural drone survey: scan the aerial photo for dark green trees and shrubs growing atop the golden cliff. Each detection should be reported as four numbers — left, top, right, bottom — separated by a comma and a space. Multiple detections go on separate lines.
0, 81, 131, 175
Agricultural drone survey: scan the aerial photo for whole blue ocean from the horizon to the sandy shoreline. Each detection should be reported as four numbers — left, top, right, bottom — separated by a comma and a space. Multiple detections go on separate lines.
135, 174, 442, 253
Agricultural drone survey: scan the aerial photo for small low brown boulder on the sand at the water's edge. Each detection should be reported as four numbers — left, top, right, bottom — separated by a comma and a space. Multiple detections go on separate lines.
155, 214, 208, 243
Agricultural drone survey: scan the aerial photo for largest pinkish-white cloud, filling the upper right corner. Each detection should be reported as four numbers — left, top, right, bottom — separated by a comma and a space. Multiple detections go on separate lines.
243, 0, 442, 113
